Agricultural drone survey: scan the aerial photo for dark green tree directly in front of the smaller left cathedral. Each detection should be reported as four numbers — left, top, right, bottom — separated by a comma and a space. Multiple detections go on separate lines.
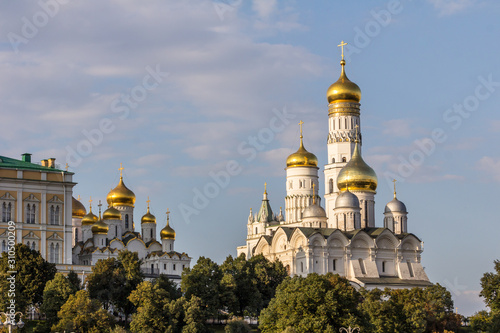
87, 250, 144, 318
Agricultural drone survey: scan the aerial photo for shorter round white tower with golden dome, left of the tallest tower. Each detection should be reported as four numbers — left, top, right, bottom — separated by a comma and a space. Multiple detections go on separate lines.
285, 121, 320, 224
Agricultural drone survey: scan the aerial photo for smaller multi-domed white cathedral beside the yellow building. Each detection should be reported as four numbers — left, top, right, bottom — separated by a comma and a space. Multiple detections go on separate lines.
72, 167, 191, 282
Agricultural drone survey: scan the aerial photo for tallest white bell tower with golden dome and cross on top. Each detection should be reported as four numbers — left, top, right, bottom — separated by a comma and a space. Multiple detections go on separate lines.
325, 41, 361, 223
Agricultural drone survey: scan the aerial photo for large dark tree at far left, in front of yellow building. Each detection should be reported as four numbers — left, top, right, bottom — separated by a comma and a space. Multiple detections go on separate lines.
0, 244, 57, 312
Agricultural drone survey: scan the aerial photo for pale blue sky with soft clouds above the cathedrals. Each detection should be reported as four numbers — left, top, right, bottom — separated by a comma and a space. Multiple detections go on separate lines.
0, 0, 500, 315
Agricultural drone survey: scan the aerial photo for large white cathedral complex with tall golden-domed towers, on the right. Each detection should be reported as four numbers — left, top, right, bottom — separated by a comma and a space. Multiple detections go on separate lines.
237, 50, 431, 288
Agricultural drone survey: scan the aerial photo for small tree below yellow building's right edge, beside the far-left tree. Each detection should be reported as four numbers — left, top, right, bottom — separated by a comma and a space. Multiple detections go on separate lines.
40, 273, 77, 327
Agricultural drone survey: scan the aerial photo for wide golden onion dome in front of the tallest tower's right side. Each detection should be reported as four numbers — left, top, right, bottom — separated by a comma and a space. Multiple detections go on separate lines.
337, 141, 378, 192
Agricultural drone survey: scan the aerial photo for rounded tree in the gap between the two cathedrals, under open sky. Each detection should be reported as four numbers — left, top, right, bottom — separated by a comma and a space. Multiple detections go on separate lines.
181, 257, 224, 317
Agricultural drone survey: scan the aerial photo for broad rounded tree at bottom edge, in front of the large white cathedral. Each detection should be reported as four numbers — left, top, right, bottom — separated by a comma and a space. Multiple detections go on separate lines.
259, 273, 366, 332
